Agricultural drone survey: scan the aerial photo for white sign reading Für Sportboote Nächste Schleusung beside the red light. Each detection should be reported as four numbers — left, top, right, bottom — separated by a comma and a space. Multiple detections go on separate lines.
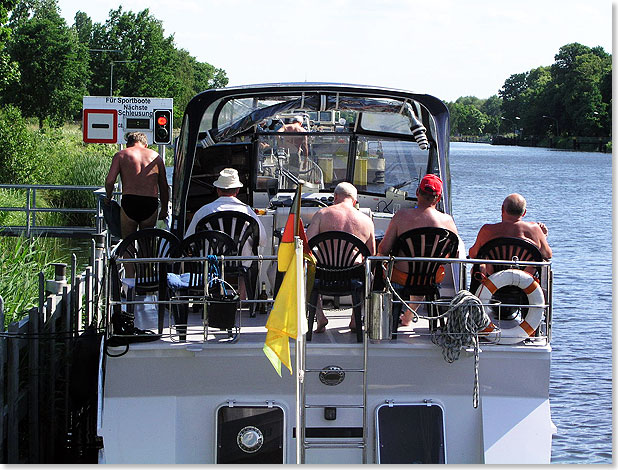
83, 96, 174, 145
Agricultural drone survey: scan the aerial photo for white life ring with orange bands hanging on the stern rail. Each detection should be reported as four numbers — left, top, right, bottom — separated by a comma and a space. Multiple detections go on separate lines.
476, 269, 545, 344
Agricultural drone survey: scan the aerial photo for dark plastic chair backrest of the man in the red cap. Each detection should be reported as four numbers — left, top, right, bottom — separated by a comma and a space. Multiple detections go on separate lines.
391, 227, 459, 295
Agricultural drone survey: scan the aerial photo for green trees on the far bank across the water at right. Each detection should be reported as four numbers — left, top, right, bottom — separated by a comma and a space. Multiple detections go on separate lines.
447, 43, 612, 137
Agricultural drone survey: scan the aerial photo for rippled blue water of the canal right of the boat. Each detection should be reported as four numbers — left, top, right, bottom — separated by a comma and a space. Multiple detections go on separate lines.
451, 143, 612, 464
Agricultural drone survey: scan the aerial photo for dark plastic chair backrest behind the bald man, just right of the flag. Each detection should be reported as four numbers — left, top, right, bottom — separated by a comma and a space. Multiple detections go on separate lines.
309, 231, 371, 294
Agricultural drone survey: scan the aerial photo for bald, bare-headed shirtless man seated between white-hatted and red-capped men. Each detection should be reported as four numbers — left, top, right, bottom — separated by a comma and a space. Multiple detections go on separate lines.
307, 182, 376, 333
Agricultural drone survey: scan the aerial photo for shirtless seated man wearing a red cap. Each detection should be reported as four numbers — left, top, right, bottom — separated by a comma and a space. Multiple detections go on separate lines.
378, 174, 457, 326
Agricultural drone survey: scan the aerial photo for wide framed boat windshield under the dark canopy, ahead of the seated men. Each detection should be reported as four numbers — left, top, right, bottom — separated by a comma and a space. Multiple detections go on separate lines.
199, 95, 435, 195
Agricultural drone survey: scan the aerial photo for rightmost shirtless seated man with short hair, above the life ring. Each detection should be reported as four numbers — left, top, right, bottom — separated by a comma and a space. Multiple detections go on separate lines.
469, 193, 552, 260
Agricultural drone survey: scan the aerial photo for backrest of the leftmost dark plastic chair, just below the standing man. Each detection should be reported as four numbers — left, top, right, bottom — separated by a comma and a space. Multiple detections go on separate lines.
111, 228, 180, 294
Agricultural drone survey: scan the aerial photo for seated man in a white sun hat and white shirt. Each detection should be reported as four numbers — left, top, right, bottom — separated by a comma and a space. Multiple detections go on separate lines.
185, 168, 266, 299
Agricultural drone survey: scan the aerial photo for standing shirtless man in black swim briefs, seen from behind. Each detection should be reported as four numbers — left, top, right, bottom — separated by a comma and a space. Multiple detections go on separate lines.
104, 132, 169, 238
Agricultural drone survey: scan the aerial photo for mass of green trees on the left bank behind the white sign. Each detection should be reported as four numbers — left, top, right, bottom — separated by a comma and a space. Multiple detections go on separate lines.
0, 0, 228, 127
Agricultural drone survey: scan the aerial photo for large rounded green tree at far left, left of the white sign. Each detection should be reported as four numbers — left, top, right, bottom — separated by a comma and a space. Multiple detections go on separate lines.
5, 0, 88, 127
